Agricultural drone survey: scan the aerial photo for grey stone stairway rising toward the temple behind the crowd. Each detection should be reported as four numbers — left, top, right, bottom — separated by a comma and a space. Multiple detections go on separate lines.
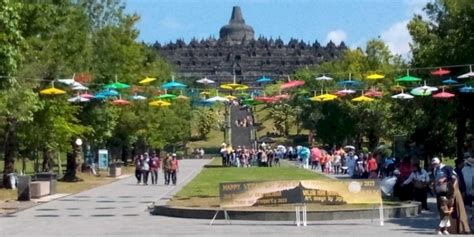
230, 106, 253, 148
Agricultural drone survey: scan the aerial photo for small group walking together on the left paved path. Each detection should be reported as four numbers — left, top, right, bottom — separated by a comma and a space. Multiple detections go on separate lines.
135, 152, 179, 185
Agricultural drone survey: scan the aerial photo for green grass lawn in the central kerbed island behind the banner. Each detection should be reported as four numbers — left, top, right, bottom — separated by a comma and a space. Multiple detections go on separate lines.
169, 158, 325, 207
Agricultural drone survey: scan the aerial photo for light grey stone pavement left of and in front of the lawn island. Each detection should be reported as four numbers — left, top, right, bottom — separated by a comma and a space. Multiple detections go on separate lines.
0, 160, 462, 237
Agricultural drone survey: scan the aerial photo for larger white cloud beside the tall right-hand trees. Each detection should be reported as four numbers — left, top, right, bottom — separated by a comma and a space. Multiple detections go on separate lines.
380, 20, 411, 57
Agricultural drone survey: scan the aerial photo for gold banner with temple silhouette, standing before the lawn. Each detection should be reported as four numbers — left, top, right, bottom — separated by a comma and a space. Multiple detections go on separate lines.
219, 179, 382, 207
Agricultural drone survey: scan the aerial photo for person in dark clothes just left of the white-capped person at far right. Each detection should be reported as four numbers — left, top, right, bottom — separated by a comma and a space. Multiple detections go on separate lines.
402, 162, 430, 210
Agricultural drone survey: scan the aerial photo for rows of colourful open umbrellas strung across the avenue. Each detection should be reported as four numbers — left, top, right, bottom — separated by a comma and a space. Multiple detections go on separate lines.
40, 66, 474, 107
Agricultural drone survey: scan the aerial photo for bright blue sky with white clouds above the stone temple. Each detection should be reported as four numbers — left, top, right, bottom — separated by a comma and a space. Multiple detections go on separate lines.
125, 0, 430, 57
